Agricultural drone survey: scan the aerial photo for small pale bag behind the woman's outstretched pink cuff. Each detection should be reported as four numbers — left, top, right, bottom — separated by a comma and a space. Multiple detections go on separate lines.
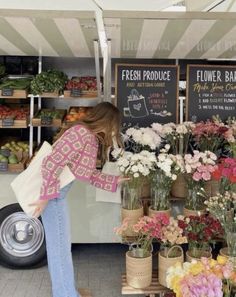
96, 161, 121, 203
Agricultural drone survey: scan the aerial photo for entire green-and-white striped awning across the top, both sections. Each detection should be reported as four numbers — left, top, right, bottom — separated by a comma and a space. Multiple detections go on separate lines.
0, 0, 236, 59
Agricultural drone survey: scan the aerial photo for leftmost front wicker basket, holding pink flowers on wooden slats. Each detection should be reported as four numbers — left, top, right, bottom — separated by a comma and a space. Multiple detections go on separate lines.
126, 251, 152, 289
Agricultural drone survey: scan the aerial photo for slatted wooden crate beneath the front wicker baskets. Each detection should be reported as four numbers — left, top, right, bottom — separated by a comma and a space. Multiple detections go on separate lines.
121, 270, 171, 297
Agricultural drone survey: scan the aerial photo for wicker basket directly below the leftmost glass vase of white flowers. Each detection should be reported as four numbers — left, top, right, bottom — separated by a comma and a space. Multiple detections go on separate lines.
121, 207, 143, 236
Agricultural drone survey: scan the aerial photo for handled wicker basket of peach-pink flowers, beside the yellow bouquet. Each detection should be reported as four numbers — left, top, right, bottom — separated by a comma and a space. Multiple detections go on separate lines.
158, 245, 184, 287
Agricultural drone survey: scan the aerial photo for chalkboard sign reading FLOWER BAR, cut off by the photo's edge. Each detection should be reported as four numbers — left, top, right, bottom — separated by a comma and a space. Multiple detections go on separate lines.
186, 65, 236, 122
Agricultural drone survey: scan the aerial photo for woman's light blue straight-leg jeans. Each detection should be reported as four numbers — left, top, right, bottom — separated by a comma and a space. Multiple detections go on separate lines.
42, 183, 79, 297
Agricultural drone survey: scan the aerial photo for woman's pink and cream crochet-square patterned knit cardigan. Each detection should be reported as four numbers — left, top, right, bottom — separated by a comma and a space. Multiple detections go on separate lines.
40, 125, 118, 200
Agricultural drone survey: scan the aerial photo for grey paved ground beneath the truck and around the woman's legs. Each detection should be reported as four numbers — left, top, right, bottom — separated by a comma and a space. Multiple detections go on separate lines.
0, 243, 144, 297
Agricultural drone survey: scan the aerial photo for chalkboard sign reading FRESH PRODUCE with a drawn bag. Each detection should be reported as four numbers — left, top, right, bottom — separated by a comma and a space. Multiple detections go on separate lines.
115, 64, 179, 127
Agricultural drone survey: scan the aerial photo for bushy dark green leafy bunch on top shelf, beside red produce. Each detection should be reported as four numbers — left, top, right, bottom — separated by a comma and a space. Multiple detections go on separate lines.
30, 70, 68, 95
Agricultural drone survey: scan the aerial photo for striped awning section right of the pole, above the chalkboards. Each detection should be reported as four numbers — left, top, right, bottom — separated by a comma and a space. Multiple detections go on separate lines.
103, 11, 236, 59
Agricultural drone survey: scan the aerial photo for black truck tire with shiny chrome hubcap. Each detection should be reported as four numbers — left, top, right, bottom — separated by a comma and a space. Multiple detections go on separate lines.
0, 204, 46, 268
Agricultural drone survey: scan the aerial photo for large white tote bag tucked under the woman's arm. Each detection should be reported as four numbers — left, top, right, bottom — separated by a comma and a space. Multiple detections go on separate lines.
11, 141, 75, 216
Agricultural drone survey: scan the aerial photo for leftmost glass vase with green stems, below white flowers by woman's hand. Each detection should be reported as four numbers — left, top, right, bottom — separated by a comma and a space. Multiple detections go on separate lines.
122, 182, 142, 210
